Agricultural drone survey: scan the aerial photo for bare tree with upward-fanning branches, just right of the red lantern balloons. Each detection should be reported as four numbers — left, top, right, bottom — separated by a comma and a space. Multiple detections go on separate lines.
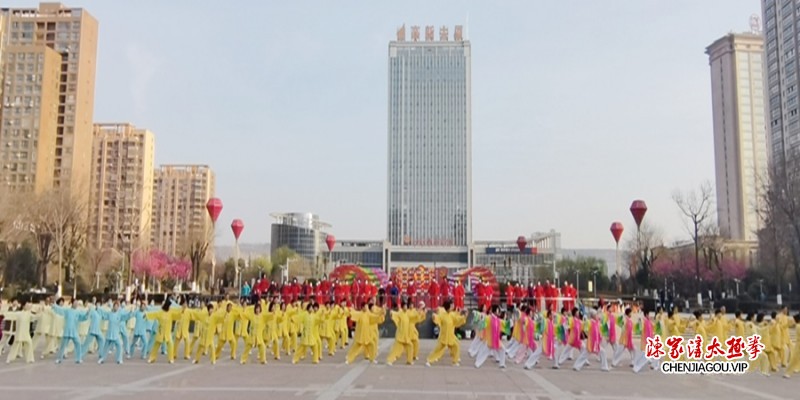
672, 182, 714, 292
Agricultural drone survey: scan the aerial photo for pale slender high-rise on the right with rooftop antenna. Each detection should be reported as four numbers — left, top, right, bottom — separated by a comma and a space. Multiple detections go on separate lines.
706, 33, 769, 241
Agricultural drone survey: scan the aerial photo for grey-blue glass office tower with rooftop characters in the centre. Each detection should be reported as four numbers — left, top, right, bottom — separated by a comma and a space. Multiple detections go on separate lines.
387, 26, 472, 248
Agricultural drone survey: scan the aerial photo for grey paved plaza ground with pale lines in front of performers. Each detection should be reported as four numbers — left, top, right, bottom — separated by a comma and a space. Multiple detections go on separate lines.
0, 339, 800, 400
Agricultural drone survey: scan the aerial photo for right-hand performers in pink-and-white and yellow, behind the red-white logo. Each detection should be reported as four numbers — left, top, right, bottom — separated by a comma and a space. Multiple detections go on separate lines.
462, 305, 800, 378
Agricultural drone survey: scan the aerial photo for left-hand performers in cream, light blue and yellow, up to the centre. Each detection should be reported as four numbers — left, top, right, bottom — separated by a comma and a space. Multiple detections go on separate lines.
0, 298, 432, 364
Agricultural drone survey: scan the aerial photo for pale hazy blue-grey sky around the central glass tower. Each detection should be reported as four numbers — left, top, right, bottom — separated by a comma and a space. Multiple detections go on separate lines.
10, 0, 760, 248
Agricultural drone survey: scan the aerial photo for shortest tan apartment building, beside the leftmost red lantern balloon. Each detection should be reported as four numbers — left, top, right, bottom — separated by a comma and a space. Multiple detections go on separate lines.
151, 165, 216, 255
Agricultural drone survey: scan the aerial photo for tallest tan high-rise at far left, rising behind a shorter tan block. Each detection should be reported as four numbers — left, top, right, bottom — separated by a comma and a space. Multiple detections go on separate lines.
0, 3, 97, 197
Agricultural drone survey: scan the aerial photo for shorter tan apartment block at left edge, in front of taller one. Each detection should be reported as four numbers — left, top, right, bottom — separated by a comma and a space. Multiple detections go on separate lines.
0, 45, 61, 193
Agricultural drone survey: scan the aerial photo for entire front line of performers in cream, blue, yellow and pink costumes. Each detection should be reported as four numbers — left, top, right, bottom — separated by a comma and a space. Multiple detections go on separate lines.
3, 300, 800, 377
